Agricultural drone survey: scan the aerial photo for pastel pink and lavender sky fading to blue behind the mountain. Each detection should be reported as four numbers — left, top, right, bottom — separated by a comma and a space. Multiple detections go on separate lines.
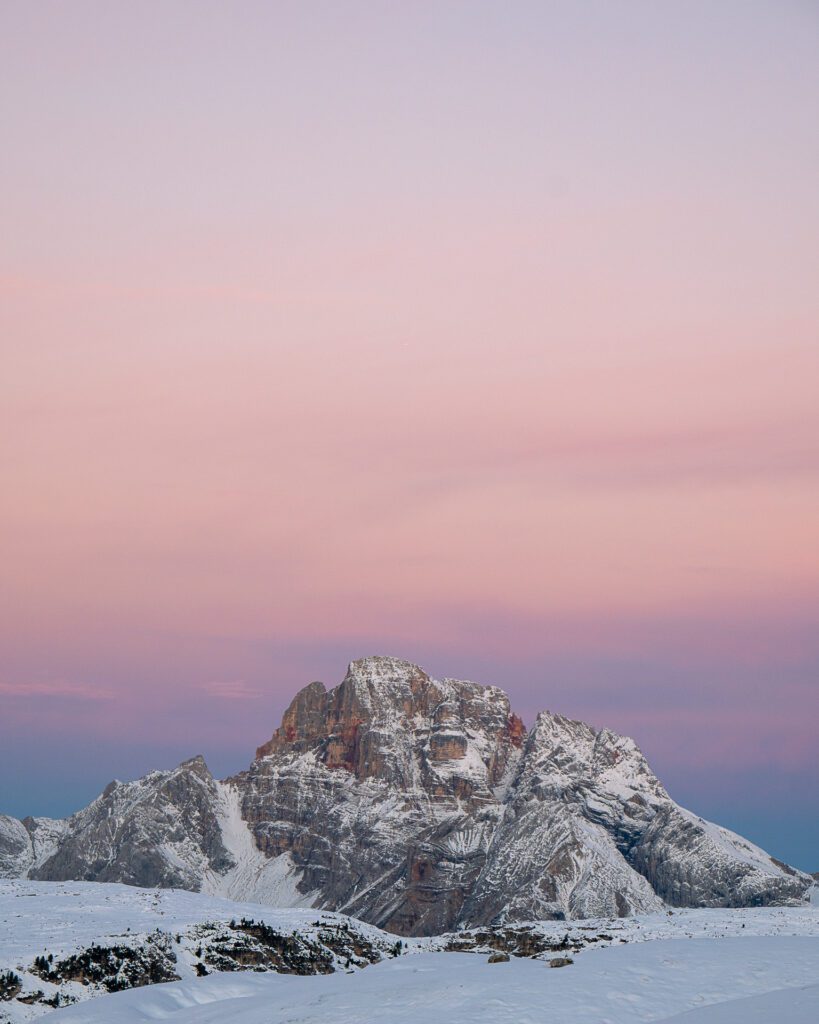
0, 0, 819, 870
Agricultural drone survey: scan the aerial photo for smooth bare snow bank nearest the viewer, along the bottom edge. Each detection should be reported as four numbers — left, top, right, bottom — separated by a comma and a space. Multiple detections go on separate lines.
47, 936, 819, 1024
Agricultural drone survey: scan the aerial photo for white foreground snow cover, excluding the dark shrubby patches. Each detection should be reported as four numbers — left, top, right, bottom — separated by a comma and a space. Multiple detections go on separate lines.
0, 880, 819, 1024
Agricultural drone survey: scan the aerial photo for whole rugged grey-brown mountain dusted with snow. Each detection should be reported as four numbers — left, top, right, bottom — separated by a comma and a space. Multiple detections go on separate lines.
0, 657, 812, 935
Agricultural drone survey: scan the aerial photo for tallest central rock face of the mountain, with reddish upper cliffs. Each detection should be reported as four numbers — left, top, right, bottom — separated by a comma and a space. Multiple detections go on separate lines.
242, 657, 524, 934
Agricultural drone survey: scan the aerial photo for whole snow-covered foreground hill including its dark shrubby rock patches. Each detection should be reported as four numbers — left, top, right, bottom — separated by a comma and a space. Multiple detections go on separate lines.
0, 881, 819, 1024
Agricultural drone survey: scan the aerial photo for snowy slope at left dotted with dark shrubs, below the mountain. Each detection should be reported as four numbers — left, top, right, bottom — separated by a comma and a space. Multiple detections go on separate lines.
0, 881, 397, 1024
